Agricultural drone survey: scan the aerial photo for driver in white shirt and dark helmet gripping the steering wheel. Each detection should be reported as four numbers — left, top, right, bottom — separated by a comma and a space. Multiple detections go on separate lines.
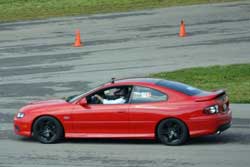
94, 88, 128, 104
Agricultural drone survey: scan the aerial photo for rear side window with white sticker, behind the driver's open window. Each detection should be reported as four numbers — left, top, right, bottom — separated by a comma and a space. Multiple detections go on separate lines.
131, 86, 167, 103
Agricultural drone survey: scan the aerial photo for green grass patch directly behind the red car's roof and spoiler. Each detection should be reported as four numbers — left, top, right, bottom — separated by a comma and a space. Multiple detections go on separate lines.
150, 64, 250, 103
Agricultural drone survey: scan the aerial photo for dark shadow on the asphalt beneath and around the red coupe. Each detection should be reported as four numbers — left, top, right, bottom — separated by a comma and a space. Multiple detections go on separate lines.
9, 128, 250, 145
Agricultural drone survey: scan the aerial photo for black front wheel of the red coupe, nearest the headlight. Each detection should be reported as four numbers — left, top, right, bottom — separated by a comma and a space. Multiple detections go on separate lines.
32, 116, 64, 144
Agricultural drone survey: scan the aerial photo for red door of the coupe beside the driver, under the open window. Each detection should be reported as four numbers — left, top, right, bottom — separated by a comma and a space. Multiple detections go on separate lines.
72, 87, 132, 137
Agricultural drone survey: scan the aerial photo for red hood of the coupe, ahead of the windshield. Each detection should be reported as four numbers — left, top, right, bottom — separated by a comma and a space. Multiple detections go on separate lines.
21, 99, 68, 111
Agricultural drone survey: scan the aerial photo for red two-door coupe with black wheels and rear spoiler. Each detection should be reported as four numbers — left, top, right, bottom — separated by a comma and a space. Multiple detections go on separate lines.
14, 78, 232, 145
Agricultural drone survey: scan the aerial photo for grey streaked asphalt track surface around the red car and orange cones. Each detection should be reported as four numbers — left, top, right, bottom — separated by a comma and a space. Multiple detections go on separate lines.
0, 1, 250, 167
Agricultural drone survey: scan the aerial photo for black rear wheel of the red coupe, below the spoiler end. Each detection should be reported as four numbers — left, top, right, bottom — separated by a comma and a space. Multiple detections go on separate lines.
157, 118, 189, 146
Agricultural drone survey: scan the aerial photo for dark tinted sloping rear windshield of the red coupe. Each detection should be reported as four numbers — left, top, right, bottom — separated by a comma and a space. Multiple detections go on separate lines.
156, 80, 203, 96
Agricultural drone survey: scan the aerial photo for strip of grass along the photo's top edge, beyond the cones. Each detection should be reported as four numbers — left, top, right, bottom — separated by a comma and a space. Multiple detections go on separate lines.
0, 0, 240, 22
